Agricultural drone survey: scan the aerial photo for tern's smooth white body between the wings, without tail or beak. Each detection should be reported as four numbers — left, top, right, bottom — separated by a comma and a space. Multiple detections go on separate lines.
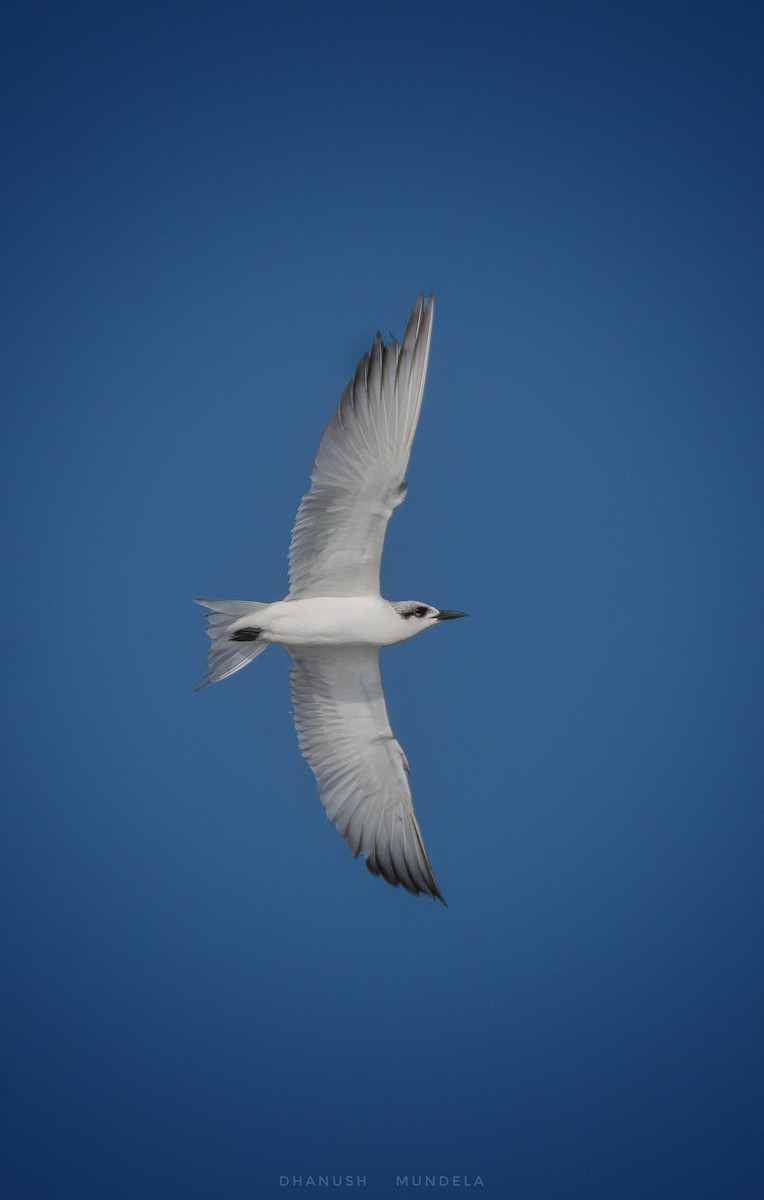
229, 595, 429, 649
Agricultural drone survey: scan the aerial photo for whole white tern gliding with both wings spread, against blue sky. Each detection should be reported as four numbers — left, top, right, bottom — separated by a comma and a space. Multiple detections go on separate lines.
195, 295, 467, 904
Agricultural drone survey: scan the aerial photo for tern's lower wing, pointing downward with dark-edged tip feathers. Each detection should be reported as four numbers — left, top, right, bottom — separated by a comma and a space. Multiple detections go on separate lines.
289, 646, 445, 904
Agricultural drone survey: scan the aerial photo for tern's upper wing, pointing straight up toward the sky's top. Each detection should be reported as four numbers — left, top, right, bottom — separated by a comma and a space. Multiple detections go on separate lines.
289, 296, 434, 599
